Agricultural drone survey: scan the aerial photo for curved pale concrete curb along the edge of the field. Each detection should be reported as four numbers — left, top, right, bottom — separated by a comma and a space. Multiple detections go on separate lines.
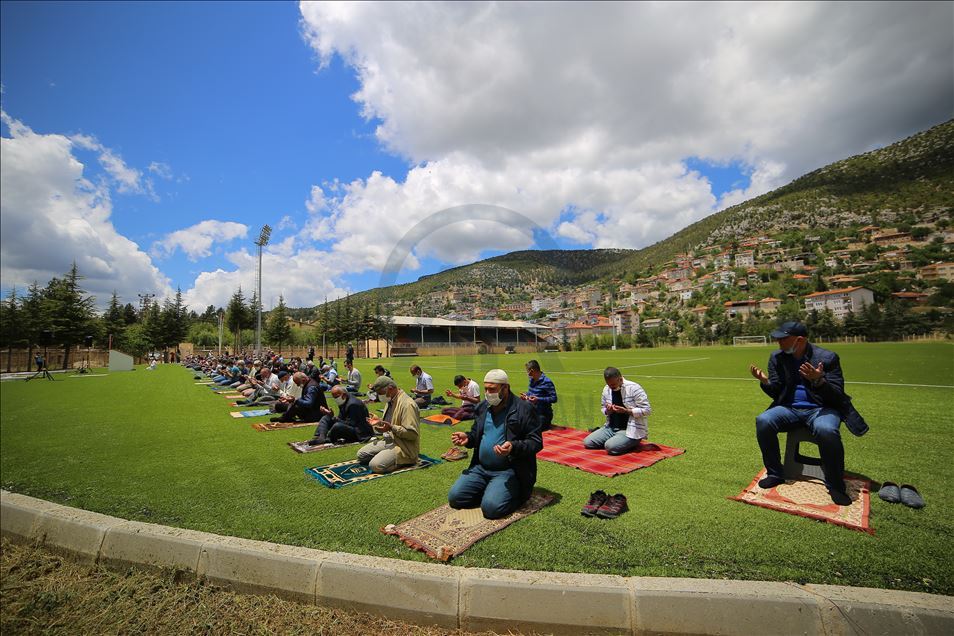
0, 491, 954, 636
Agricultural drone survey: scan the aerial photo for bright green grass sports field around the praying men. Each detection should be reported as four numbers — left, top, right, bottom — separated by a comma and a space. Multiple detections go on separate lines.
0, 343, 954, 594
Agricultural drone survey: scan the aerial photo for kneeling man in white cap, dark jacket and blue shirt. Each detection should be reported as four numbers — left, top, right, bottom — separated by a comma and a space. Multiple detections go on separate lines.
447, 369, 543, 519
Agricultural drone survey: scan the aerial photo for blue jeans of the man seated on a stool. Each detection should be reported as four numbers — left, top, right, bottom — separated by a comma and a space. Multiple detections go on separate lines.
755, 406, 845, 492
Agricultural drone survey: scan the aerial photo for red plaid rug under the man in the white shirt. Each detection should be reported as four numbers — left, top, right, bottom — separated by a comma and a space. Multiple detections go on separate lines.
537, 426, 686, 477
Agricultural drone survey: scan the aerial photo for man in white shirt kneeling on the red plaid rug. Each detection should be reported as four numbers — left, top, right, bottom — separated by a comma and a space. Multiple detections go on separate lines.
583, 367, 652, 455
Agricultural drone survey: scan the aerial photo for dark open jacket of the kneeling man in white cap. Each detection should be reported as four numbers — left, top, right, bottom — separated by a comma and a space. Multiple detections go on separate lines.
465, 393, 543, 503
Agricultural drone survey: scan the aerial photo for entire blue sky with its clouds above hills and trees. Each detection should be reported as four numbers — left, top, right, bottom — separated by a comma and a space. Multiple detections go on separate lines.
0, 2, 954, 309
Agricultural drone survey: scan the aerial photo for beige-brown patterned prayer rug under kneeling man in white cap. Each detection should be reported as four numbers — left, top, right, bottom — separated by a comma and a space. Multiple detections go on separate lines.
381, 490, 553, 561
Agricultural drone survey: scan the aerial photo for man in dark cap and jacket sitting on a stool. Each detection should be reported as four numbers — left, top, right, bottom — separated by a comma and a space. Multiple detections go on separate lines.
749, 322, 868, 506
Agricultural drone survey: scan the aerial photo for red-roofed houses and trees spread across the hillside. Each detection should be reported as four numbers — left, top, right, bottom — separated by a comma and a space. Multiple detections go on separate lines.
378, 215, 954, 342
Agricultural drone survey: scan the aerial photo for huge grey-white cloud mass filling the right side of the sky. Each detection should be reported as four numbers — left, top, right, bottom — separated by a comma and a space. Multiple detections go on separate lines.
300, 2, 954, 269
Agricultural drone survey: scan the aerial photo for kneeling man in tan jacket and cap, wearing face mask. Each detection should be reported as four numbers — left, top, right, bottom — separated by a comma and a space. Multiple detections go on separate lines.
358, 375, 421, 473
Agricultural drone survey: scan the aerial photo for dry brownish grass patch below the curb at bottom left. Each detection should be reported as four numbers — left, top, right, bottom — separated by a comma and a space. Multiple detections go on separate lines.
0, 539, 520, 636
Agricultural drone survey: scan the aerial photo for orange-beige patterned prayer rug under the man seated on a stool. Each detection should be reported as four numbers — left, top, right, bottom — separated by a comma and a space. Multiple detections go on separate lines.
729, 468, 874, 534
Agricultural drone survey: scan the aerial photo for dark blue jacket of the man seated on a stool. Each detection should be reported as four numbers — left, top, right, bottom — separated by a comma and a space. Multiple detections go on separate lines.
759, 343, 868, 436
